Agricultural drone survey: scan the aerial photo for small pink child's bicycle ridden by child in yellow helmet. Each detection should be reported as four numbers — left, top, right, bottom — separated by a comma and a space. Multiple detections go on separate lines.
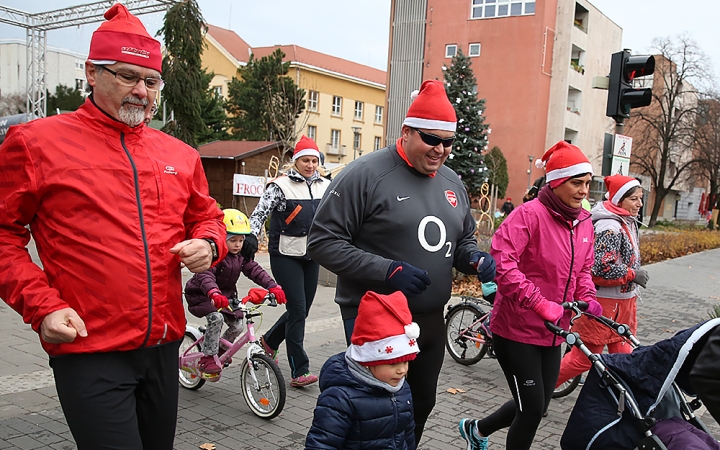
179, 292, 286, 420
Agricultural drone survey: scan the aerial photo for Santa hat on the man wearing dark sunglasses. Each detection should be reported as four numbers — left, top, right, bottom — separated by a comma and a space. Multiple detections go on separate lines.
403, 80, 457, 131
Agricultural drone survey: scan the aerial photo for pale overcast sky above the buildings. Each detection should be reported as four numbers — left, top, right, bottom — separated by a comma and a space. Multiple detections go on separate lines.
0, 0, 720, 81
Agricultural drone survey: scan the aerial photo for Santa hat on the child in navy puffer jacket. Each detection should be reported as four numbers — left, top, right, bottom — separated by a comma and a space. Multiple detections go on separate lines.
349, 291, 420, 366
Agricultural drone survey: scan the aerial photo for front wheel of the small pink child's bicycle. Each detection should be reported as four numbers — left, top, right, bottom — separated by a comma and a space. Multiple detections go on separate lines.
240, 353, 285, 420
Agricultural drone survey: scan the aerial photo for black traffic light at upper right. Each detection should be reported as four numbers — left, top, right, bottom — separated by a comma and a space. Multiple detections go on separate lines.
605, 50, 655, 120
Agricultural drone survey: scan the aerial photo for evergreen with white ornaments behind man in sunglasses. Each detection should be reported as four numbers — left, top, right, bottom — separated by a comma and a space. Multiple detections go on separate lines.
443, 49, 490, 197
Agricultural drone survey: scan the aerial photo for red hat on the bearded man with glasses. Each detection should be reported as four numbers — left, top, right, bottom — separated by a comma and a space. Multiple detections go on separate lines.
88, 3, 162, 72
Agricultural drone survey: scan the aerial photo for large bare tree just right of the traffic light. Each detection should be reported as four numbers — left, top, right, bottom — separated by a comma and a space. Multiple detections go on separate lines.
626, 36, 711, 227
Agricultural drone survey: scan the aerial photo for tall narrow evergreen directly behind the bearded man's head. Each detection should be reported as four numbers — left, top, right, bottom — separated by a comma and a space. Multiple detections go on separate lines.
158, 0, 207, 148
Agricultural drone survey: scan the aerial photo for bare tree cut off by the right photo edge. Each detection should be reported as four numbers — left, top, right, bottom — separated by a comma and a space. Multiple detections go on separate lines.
695, 93, 720, 221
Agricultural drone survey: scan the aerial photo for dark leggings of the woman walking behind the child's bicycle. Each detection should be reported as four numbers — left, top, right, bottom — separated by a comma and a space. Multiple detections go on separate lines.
263, 255, 320, 378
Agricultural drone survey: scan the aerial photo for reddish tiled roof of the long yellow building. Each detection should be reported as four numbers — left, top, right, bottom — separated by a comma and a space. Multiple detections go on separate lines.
208, 24, 386, 87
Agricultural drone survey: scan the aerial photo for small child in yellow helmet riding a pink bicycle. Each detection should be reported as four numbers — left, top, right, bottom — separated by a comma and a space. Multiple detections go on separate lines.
185, 209, 286, 375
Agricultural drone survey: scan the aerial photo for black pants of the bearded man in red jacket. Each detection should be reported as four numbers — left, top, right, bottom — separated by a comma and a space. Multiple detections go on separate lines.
50, 341, 180, 450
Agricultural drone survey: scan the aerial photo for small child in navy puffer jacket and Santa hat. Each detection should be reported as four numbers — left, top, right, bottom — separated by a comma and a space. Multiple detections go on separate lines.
305, 291, 420, 449
